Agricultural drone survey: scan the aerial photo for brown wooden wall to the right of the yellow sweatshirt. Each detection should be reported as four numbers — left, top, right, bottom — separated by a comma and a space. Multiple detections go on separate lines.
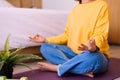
106, 0, 120, 44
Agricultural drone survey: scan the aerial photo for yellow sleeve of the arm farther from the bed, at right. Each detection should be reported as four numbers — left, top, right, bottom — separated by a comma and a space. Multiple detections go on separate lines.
92, 5, 109, 51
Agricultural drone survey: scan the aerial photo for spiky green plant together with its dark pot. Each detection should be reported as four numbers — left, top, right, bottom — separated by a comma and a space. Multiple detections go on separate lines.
0, 35, 42, 78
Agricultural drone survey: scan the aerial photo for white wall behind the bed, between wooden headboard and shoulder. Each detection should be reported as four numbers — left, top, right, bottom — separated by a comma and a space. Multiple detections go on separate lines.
42, 0, 76, 10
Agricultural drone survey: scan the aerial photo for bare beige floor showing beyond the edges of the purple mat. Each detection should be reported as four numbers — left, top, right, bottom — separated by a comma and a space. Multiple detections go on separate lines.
13, 45, 120, 74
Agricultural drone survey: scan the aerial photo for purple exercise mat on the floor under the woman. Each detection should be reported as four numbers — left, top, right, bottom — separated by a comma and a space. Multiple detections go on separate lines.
14, 58, 120, 80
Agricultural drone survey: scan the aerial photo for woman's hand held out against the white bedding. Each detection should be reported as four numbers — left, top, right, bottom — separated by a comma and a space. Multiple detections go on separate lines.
29, 34, 47, 43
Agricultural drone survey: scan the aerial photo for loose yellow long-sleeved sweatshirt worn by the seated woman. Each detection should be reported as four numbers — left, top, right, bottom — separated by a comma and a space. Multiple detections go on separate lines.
47, 0, 110, 58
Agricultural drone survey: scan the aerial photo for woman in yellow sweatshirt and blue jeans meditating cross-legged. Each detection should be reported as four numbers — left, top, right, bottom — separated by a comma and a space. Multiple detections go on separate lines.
29, 0, 110, 77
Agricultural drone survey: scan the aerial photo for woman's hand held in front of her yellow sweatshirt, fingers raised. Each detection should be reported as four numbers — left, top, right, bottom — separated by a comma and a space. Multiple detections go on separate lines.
78, 38, 97, 52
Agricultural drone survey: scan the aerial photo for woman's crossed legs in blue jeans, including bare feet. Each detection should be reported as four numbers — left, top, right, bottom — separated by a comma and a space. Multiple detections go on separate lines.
37, 43, 107, 77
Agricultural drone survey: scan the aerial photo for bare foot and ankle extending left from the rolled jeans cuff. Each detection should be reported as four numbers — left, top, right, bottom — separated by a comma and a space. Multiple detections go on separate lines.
37, 62, 58, 72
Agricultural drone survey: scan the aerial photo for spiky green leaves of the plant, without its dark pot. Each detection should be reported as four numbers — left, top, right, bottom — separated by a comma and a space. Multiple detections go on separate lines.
0, 35, 42, 70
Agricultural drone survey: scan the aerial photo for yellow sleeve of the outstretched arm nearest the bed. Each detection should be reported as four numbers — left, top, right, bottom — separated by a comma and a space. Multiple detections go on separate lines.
47, 16, 69, 44
